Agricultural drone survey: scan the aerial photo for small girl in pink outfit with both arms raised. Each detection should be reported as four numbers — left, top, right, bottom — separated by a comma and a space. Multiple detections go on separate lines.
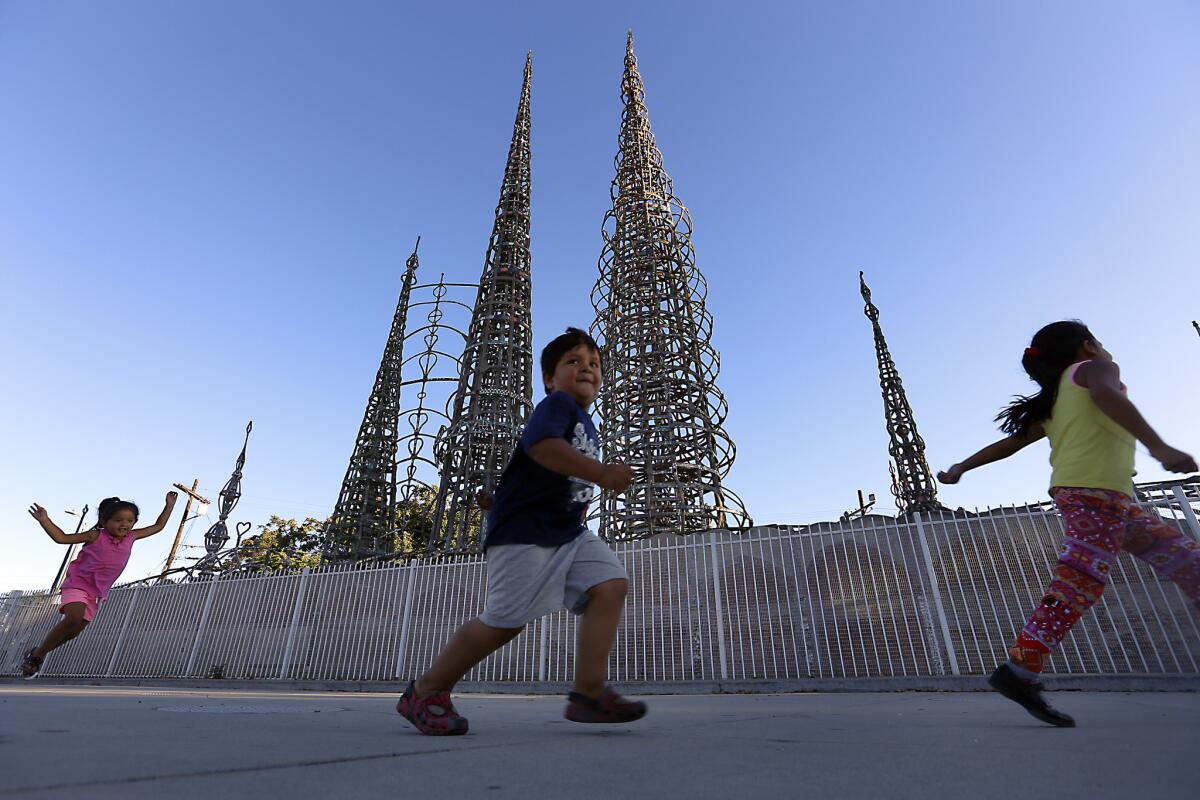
20, 492, 179, 680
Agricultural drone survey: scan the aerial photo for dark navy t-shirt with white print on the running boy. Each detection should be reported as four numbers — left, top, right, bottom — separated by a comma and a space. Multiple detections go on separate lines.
484, 392, 600, 549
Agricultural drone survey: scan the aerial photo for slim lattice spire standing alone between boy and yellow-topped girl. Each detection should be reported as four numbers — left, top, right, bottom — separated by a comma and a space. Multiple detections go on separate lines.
858, 272, 942, 513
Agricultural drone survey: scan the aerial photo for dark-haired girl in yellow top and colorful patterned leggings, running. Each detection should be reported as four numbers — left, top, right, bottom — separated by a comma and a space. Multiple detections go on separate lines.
937, 320, 1200, 727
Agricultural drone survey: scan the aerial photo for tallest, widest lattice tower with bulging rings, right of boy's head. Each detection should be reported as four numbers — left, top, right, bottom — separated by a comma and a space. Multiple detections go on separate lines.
592, 31, 751, 541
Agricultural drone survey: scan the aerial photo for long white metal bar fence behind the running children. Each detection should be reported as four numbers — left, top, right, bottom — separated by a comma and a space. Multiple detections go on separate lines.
0, 487, 1200, 682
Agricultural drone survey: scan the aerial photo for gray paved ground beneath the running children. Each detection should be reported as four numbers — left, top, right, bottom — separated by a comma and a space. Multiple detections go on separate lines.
0, 682, 1200, 800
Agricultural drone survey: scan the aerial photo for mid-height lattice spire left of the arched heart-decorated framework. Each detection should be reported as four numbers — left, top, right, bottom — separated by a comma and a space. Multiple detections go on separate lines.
325, 237, 421, 559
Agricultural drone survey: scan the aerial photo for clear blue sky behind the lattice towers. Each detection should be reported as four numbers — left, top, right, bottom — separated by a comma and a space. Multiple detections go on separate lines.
0, 0, 1200, 589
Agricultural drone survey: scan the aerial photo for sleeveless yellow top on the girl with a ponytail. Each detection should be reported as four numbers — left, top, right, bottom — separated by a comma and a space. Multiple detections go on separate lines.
1042, 361, 1135, 497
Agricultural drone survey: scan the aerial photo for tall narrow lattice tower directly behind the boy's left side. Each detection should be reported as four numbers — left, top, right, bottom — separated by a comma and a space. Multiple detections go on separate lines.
430, 53, 533, 552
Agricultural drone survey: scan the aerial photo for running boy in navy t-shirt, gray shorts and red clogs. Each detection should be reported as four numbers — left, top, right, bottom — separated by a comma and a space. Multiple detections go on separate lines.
396, 327, 646, 735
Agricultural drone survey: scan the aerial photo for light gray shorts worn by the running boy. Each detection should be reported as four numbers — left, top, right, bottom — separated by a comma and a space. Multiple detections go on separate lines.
479, 530, 629, 627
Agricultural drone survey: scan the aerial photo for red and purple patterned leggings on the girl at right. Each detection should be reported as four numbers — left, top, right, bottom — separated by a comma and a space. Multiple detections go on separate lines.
1008, 487, 1200, 673
